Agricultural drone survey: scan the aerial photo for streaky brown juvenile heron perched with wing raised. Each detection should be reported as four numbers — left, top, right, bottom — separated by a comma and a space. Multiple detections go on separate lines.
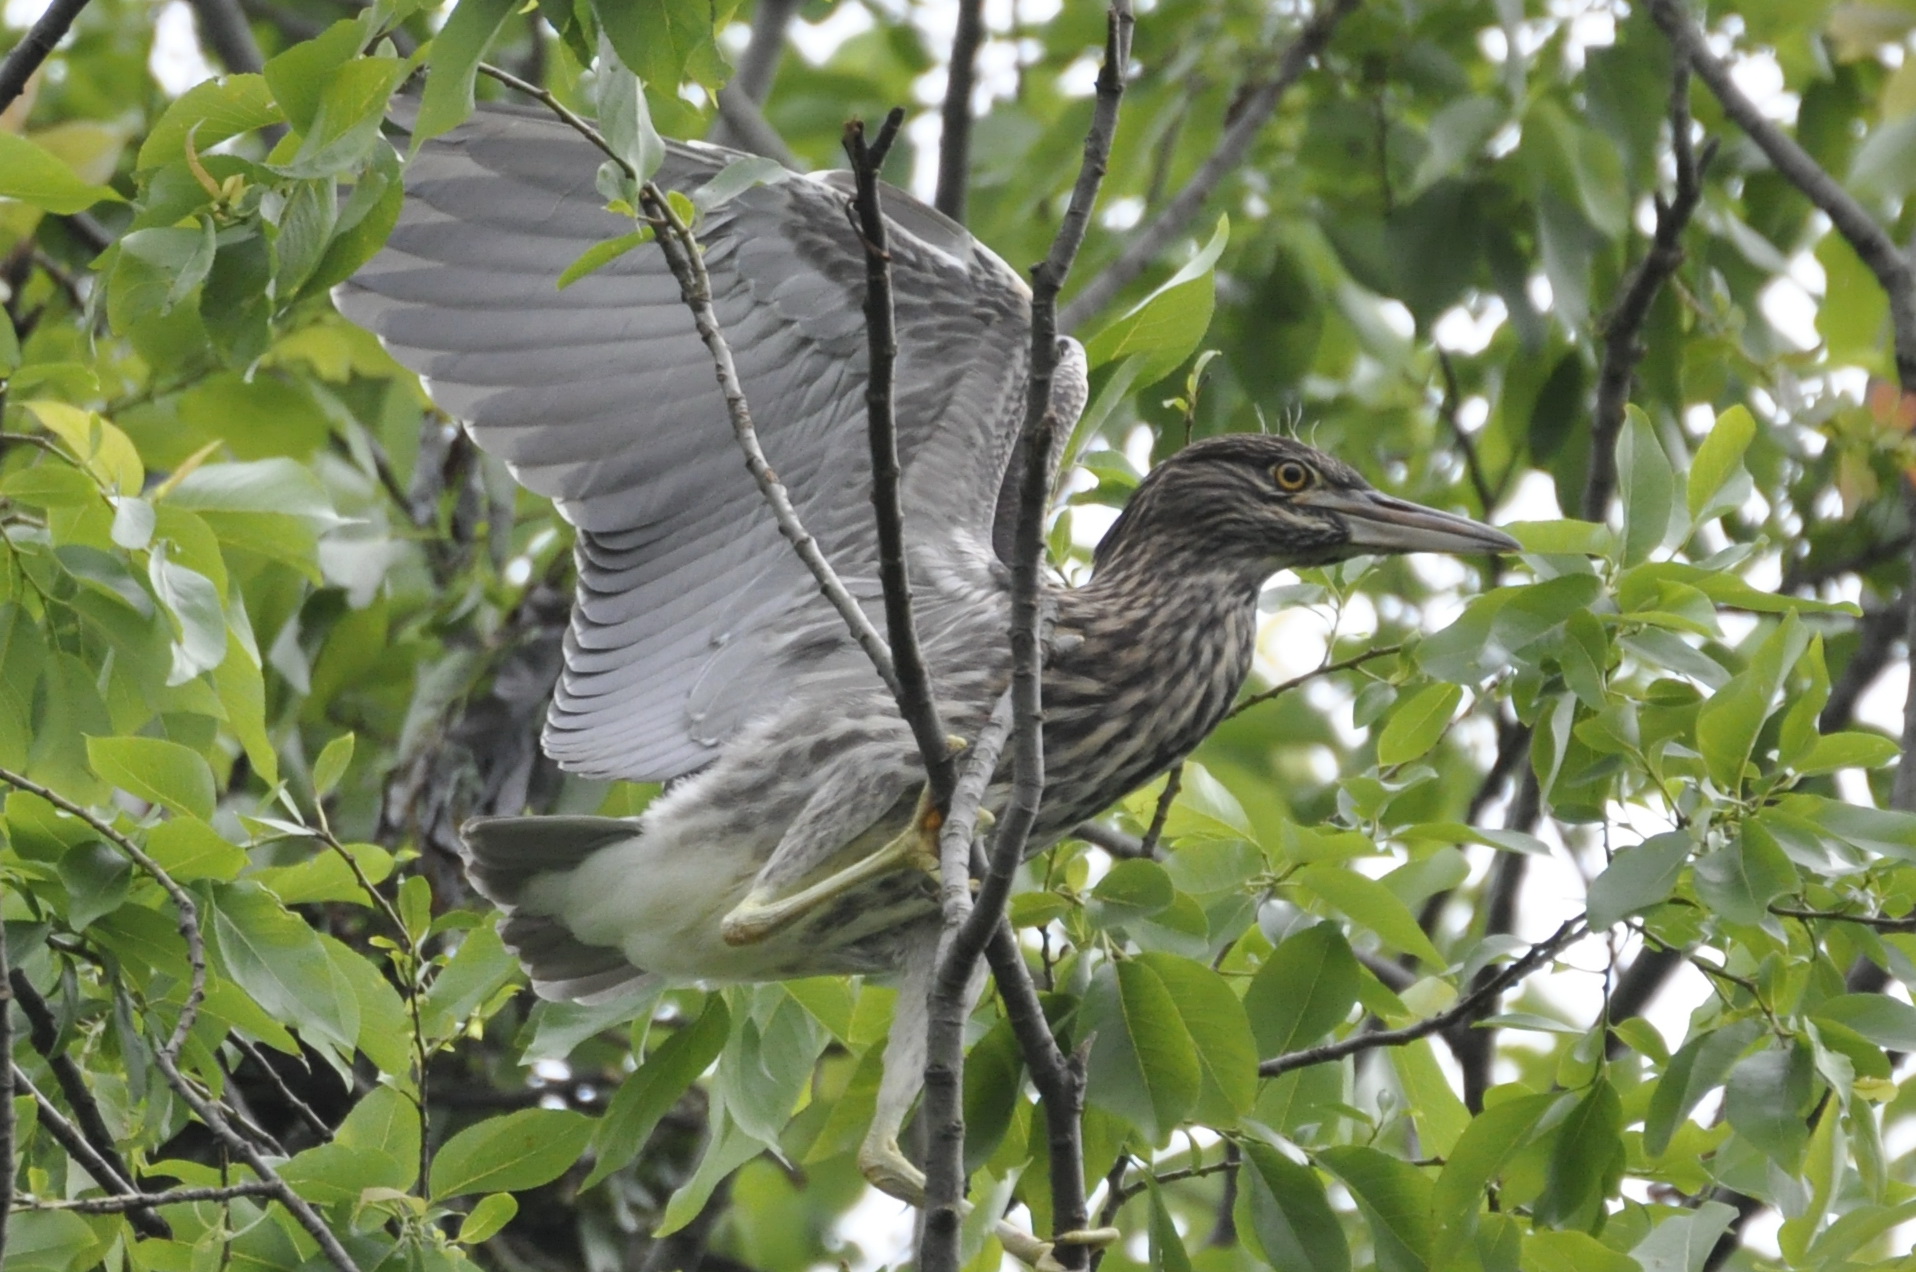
337, 109, 1516, 1255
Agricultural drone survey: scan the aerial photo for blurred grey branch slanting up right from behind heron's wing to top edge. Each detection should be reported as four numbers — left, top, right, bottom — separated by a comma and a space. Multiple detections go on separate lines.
1058, 0, 1358, 331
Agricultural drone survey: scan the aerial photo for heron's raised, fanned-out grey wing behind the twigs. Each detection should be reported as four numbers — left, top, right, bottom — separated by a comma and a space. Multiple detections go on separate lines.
335, 107, 1029, 780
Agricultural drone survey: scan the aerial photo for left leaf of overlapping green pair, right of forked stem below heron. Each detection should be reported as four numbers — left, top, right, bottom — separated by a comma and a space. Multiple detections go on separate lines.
1083, 958, 1203, 1144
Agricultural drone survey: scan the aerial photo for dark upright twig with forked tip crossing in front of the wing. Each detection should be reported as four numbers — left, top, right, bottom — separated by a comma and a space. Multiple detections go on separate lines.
845, 107, 958, 808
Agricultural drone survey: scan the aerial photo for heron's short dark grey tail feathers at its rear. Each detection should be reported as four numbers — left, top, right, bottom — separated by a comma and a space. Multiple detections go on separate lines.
460, 816, 650, 1004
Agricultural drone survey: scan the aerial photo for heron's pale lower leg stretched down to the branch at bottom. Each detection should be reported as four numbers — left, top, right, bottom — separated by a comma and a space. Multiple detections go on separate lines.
858, 923, 1119, 1272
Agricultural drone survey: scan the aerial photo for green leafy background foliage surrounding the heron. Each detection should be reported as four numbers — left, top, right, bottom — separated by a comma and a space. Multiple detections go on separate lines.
0, 0, 1916, 1272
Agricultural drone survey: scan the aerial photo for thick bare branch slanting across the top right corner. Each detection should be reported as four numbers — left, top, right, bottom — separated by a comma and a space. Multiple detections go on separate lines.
1650, 0, 1916, 389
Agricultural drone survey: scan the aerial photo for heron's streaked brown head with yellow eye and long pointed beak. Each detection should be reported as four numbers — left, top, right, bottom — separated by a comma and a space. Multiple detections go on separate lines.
1096, 433, 1517, 580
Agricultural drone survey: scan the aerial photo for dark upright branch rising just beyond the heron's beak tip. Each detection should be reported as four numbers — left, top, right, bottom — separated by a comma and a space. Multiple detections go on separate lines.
1581, 59, 1717, 521
